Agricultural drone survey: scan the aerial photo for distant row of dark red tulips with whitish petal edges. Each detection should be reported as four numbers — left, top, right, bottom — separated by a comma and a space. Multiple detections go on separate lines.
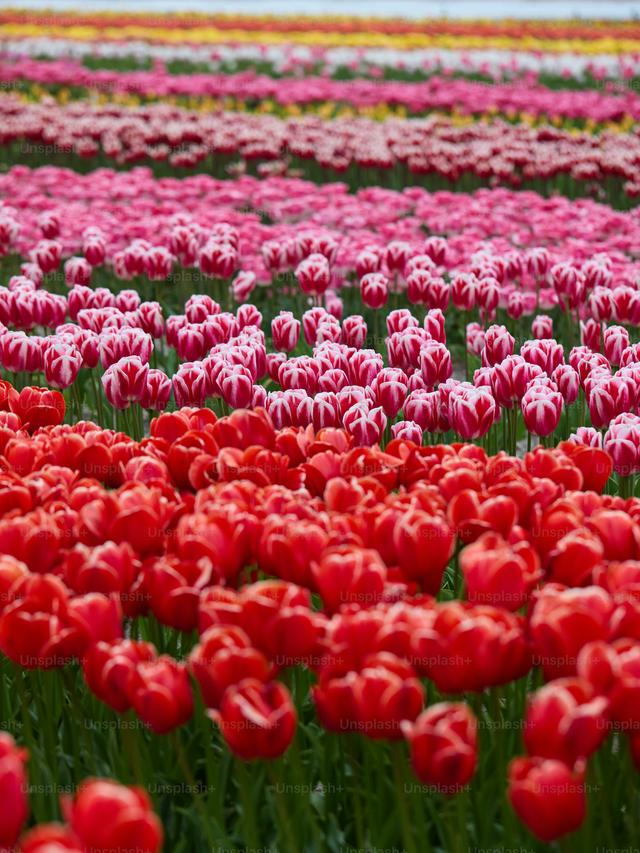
0, 100, 640, 205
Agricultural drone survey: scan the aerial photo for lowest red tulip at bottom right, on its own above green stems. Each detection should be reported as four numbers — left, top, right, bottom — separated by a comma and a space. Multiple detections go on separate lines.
509, 758, 586, 842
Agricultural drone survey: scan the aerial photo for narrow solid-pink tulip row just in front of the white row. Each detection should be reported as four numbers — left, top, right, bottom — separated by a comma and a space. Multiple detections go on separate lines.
0, 59, 640, 124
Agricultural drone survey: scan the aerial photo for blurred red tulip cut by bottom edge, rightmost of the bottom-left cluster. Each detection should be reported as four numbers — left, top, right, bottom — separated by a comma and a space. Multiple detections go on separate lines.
64, 779, 162, 853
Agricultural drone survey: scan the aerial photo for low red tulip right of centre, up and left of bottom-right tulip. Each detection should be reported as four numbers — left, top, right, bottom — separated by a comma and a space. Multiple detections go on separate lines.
402, 702, 478, 794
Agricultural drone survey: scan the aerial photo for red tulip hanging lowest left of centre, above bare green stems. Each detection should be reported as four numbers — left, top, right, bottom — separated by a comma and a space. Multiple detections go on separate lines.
212, 678, 297, 761
